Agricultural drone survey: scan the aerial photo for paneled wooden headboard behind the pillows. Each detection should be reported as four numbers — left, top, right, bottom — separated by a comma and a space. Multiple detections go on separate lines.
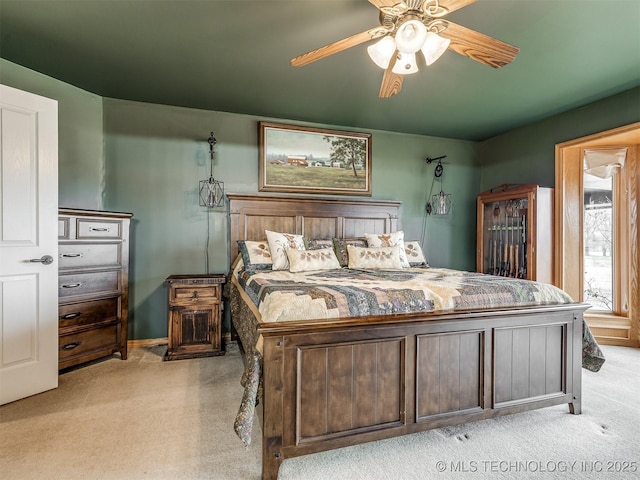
227, 193, 401, 262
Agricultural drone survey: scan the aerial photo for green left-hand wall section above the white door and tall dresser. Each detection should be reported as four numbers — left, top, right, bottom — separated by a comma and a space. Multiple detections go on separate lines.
0, 59, 105, 210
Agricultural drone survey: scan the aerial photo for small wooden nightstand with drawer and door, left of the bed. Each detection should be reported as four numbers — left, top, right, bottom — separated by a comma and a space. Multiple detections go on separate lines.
165, 274, 226, 360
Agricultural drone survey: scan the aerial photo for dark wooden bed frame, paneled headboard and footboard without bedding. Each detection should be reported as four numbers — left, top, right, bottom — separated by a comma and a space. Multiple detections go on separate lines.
228, 194, 586, 480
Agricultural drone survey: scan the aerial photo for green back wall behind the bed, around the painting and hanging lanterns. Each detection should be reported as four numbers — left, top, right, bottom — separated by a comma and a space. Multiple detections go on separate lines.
104, 98, 479, 338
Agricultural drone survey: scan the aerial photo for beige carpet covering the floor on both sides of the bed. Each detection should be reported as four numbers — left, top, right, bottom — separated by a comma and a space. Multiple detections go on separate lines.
0, 347, 640, 480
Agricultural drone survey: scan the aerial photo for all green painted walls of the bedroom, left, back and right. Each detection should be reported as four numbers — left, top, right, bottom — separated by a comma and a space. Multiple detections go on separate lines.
5, 59, 640, 339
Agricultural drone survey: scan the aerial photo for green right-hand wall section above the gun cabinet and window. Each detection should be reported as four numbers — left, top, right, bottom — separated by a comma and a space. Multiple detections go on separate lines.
479, 87, 640, 191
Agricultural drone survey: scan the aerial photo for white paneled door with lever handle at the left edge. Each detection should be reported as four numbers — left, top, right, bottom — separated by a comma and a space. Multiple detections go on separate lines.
0, 85, 58, 405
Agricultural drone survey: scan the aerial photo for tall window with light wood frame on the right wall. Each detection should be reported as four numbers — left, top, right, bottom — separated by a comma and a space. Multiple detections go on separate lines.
554, 124, 640, 346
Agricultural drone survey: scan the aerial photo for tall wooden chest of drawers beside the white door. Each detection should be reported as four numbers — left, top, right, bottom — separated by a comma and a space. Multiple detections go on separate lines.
58, 208, 132, 369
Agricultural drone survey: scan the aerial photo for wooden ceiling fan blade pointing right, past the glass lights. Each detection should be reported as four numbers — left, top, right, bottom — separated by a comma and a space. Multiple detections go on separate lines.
439, 21, 520, 68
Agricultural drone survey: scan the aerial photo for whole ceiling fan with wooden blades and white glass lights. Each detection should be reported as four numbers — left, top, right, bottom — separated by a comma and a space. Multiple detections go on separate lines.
291, 0, 519, 98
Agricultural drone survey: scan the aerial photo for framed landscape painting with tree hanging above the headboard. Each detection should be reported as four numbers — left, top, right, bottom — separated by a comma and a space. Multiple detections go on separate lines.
258, 122, 371, 196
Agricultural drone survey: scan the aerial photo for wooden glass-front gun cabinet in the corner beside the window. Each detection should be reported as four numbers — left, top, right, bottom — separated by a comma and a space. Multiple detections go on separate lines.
476, 184, 553, 283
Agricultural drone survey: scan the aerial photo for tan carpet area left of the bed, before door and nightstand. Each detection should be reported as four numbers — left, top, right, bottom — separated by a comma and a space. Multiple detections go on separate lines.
0, 347, 261, 480
